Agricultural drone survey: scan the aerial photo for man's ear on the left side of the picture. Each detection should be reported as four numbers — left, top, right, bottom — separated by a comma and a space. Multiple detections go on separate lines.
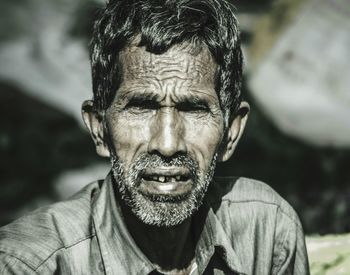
81, 100, 110, 157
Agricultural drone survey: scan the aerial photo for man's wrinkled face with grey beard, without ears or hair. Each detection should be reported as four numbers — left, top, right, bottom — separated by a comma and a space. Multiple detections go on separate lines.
106, 45, 224, 226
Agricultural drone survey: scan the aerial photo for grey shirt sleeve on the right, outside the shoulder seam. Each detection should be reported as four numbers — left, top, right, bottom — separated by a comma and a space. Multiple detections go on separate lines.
272, 209, 310, 275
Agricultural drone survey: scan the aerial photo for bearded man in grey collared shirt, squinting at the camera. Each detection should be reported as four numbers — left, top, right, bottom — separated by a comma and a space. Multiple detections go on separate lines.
0, 0, 308, 275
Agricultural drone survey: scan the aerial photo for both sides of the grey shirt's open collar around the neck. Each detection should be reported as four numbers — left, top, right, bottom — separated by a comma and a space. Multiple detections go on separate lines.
92, 174, 247, 274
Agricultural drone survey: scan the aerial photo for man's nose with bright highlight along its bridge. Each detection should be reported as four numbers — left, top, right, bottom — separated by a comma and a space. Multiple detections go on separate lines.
148, 107, 187, 157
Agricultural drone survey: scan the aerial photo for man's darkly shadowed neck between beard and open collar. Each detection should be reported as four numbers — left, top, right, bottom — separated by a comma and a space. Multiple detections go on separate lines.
121, 203, 195, 274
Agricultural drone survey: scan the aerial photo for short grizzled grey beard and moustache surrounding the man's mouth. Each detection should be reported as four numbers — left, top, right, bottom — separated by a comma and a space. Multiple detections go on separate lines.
112, 155, 216, 227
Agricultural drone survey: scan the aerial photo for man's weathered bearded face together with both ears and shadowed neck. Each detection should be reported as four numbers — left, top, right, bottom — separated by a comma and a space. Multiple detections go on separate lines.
83, 44, 249, 274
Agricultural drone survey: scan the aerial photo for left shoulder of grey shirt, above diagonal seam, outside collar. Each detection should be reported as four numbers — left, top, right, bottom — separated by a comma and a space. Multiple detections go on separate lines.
0, 182, 99, 269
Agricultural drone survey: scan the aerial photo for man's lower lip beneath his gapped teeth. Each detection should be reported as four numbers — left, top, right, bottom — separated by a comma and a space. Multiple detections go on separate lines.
139, 179, 192, 196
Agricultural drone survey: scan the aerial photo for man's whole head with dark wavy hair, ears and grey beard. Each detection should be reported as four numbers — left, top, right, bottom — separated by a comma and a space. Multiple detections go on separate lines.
83, 0, 249, 226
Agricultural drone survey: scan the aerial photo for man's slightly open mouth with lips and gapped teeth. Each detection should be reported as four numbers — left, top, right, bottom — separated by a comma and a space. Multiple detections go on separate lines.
139, 167, 193, 197
